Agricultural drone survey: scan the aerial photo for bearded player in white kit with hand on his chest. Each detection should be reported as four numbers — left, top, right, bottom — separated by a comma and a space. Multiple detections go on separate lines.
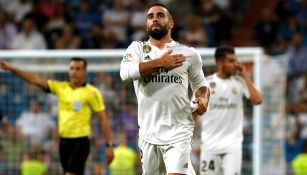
120, 4, 209, 175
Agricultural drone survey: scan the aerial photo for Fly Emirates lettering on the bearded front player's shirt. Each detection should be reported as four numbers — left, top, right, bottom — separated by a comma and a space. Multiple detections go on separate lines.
143, 68, 182, 84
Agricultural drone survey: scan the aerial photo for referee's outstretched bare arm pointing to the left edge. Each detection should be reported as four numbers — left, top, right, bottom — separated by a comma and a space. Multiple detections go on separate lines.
0, 60, 48, 90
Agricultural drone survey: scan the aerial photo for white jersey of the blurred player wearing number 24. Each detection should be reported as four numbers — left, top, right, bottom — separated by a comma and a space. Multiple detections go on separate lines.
200, 73, 249, 154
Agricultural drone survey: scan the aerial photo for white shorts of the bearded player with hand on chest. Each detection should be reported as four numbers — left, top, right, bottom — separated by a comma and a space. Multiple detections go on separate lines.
139, 139, 195, 175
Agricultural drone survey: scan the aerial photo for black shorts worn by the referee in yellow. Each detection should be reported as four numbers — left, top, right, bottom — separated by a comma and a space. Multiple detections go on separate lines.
59, 137, 90, 175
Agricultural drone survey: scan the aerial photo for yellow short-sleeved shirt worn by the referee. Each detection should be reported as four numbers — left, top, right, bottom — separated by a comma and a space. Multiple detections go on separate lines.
48, 80, 105, 138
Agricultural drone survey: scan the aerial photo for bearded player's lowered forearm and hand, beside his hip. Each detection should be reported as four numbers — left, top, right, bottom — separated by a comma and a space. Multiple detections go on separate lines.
192, 86, 210, 115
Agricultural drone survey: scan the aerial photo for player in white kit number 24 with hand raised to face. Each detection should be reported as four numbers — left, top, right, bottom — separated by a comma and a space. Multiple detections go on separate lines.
199, 46, 262, 175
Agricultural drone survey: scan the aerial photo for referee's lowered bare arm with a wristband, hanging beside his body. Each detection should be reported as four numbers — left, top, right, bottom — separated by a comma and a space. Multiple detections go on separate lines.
96, 111, 114, 165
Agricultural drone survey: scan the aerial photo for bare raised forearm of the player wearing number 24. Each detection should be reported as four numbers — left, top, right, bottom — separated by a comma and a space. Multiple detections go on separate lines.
237, 63, 262, 105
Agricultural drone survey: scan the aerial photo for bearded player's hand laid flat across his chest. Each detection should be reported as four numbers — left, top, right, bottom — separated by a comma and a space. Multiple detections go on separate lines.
160, 49, 186, 70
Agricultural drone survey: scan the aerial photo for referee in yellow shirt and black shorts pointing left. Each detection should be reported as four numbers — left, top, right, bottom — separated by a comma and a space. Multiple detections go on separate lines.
0, 58, 114, 175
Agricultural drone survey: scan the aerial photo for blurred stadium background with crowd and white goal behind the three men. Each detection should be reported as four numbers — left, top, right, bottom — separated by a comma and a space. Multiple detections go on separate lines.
0, 0, 307, 175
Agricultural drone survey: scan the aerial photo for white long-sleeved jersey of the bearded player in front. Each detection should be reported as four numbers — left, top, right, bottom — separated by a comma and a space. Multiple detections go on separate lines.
120, 41, 206, 144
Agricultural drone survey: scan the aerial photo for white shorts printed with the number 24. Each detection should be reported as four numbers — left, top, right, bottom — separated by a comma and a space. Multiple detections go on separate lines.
199, 149, 242, 175
